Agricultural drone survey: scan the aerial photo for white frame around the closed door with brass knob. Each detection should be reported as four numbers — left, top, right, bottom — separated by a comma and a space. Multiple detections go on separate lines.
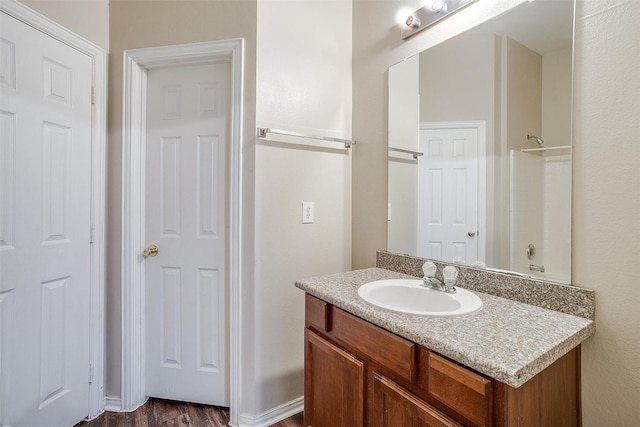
120, 38, 244, 423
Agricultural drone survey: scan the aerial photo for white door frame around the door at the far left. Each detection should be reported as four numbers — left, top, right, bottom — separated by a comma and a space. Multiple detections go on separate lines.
0, 0, 107, 419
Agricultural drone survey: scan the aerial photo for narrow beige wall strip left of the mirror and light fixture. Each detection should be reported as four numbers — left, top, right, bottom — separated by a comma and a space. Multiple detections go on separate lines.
352, 0, 405, 269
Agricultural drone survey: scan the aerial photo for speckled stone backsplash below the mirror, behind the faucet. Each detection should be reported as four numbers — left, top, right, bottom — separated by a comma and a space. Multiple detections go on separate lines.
376, 251, 595, 320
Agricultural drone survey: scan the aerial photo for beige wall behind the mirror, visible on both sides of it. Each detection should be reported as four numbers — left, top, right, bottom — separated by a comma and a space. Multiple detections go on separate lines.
353, 0, 640, 427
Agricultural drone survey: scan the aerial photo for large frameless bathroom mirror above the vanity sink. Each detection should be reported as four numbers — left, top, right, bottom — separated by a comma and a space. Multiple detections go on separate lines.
387, 0, 574, 283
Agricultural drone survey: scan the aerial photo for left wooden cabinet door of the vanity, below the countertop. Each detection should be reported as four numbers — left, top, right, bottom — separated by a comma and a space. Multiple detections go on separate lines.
304, 329, 364, 427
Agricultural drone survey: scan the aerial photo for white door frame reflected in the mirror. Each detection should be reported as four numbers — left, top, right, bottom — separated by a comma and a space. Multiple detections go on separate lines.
420, 120, 488, 262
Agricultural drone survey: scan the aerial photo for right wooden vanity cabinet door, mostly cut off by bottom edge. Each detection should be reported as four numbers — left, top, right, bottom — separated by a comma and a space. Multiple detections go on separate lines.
372, 374, 460, 427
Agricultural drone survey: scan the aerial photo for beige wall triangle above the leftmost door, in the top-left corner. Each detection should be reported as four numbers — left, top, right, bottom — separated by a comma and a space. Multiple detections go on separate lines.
22, 0, 109, 52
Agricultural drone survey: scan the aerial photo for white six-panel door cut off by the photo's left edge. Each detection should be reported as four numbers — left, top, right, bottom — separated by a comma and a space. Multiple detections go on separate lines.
0, 13, 92, 427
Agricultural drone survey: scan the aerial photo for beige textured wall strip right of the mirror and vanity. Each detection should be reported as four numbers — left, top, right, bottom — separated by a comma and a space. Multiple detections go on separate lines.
572, 0, 640, 427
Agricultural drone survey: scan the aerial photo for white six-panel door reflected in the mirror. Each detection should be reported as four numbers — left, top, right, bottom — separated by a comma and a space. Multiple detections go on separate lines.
418, 128, 479, 263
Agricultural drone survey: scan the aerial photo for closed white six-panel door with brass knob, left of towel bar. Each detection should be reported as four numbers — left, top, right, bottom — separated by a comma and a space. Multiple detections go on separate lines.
145, 64, 229, 406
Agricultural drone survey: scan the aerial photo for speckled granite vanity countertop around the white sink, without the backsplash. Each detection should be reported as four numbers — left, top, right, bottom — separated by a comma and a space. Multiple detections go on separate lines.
296, 268, 595, 387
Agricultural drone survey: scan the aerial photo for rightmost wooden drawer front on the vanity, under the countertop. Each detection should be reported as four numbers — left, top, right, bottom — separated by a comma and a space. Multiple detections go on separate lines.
428, 353, 492, 426
